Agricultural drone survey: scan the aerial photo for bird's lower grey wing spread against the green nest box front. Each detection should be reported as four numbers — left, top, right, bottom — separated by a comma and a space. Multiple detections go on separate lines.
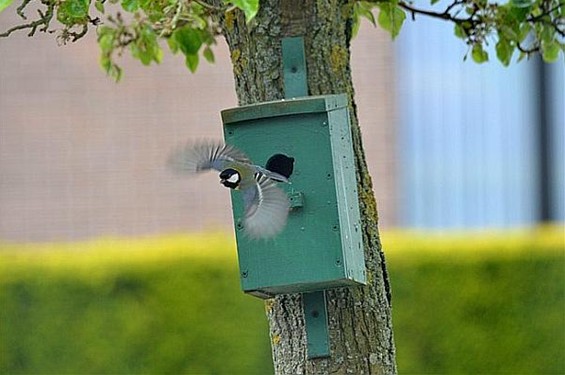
242, 174, 290, 238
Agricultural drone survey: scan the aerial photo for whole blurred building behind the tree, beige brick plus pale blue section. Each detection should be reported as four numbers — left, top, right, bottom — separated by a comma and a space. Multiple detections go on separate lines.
0, 12, 565, 242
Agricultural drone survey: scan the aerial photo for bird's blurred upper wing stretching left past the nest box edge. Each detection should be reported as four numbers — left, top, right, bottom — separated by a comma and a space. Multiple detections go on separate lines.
168, 142, 250, 173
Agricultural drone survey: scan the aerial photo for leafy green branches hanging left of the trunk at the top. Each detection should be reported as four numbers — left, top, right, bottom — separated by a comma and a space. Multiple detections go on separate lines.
0, 0, 259, 81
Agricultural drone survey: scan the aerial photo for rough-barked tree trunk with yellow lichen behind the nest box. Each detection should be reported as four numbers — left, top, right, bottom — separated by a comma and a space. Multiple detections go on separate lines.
214, 0, 396, 374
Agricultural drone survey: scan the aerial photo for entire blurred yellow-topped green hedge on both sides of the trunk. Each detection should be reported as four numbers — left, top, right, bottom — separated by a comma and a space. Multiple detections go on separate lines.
0, 227, 565, 374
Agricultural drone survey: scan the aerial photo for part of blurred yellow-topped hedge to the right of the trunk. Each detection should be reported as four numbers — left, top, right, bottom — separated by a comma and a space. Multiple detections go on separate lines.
382, 227, 565, 374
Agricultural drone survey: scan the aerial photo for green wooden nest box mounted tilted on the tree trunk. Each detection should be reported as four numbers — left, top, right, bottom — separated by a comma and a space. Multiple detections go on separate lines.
222, 95, 366, 298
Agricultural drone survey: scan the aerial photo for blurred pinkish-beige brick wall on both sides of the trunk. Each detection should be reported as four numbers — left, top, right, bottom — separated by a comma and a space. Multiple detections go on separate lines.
0, 10, 396, 241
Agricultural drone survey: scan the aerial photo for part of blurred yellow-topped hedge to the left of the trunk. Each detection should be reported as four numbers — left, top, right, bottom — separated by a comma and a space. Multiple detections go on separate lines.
0, 235, 272, 374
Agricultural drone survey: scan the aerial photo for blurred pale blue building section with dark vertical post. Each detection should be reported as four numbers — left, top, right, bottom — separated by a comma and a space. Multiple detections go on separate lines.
395, 13, 565, 229
